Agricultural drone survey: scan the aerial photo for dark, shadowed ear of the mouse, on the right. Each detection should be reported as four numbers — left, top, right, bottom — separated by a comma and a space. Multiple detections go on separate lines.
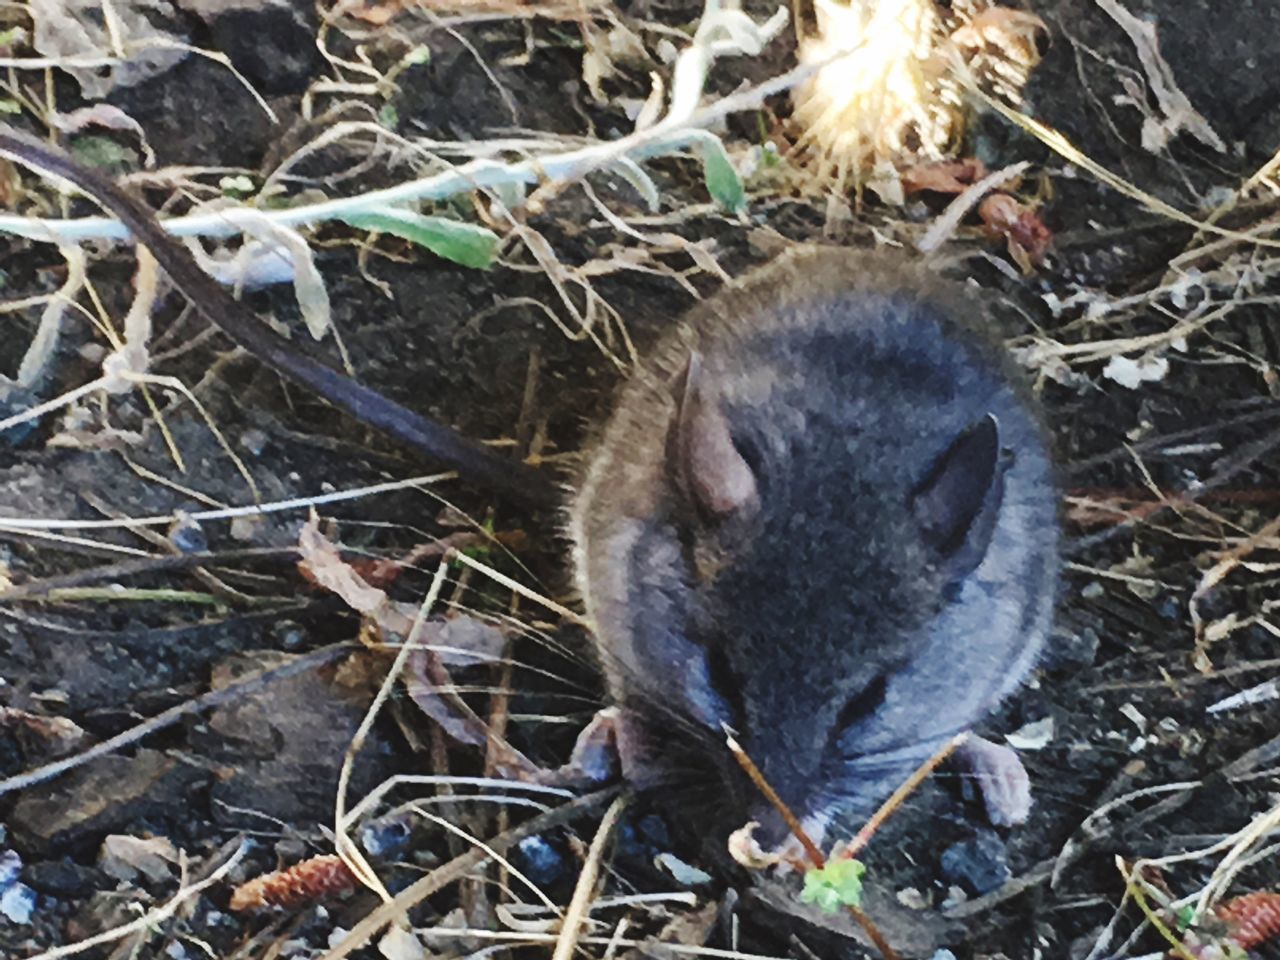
911, 413, 1005, 580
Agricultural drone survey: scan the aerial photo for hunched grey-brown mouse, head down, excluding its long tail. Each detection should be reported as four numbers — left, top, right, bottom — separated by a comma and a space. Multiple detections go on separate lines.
568, 247, 1060, 849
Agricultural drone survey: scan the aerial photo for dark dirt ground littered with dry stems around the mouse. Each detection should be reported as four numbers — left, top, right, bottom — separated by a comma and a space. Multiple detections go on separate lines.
0, 0, 1280, 960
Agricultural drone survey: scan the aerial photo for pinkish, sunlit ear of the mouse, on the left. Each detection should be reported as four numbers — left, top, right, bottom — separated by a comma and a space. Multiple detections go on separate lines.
667, 351, 758, 520
